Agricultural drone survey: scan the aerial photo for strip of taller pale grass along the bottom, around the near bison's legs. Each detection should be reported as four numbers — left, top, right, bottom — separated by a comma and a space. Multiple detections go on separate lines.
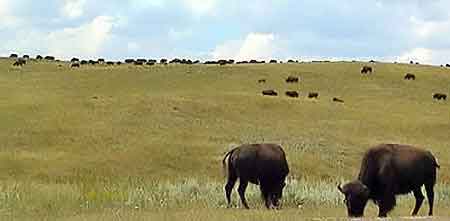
0, 178, 450, 217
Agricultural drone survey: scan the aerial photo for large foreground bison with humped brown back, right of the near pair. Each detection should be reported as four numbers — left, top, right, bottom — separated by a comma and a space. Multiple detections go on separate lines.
338, 144, 439, 217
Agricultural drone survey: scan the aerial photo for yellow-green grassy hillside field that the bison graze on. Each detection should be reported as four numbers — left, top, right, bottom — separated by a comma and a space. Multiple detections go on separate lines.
0, 59, 450, 220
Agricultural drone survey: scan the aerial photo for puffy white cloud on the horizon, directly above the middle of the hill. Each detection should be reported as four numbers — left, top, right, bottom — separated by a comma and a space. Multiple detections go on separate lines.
211, 33, 279, 60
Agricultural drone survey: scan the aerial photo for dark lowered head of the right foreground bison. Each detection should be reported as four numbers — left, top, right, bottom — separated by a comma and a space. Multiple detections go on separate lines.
338, 181, 370, 217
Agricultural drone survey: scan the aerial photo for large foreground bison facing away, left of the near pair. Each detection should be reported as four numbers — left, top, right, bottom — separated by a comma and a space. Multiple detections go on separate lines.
222, 144, 289, 209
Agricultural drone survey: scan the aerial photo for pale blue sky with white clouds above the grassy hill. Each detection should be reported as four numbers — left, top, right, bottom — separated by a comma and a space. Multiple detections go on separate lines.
0, 0, 450, 64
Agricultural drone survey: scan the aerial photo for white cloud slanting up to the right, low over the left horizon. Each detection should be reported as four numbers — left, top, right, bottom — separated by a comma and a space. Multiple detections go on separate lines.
47, 16, 116, 58
